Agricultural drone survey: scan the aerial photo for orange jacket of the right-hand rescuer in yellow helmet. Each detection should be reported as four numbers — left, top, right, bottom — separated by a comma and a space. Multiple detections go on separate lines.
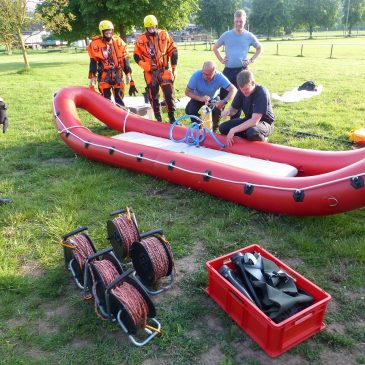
134, 29, 176, 69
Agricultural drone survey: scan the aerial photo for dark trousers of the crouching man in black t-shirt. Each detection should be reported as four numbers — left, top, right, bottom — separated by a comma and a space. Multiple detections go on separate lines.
219, 118, 274, 141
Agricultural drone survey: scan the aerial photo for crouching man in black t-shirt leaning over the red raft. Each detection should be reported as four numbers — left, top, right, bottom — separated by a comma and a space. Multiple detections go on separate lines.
219, 70, 275, 147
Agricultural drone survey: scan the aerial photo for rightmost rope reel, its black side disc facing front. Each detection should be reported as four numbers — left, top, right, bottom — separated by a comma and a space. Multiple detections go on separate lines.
131, 234, 176, 294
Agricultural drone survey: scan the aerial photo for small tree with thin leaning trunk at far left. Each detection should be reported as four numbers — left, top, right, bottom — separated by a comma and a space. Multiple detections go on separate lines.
0, 0, 31, 70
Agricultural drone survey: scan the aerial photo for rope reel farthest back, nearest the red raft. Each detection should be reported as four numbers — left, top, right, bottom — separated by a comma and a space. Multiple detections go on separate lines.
107, 207, 140, 261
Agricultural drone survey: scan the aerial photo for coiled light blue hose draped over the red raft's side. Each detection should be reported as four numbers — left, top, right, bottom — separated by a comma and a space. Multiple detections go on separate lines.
170, 115, 226, 148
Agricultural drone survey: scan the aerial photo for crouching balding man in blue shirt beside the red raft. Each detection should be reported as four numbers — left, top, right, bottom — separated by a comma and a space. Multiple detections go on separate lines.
185, 61, 237, 132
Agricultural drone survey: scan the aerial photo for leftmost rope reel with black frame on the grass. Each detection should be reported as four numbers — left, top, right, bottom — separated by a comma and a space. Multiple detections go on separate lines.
61, 226, 96, 293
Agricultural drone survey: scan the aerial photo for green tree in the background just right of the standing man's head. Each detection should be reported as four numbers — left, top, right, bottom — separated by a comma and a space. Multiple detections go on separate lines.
250, 0, 292, 39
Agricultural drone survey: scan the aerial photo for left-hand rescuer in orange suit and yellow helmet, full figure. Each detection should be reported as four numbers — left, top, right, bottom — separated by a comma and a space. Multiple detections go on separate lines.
87, 20, 134, 106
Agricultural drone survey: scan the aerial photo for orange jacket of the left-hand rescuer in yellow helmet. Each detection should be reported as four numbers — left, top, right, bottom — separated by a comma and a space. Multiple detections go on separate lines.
87, 35, 129, 71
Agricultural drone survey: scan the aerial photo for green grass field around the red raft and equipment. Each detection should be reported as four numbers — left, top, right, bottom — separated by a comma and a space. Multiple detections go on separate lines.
0, 38, 365, 365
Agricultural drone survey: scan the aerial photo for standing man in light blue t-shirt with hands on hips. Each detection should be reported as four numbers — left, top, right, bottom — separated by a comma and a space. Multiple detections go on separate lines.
213, 10, 262, 117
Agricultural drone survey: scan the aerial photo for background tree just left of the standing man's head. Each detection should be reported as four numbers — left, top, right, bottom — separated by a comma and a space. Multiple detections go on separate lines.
198, 0, 242, 36
